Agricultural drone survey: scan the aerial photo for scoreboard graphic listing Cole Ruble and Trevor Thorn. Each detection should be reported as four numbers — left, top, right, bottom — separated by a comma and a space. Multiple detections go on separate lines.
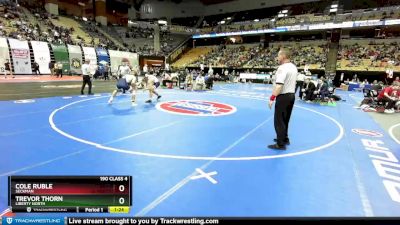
8, 176, 132, 213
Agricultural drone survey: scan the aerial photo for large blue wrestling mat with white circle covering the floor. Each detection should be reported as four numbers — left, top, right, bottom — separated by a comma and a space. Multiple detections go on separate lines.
0, 84, 400, 217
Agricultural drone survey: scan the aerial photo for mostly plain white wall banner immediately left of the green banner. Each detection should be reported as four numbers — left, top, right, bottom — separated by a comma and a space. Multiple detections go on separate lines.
31, 41, 51, 74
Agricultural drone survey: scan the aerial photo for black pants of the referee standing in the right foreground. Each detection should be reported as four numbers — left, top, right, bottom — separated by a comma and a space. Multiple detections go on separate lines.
274, 93, 295, 146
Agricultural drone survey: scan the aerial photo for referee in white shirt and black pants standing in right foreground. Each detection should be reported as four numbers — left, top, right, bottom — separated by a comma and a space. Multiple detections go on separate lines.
268, 48, 297, 150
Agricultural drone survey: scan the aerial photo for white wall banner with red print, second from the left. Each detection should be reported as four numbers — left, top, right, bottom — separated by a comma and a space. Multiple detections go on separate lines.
8, 39, 32, 74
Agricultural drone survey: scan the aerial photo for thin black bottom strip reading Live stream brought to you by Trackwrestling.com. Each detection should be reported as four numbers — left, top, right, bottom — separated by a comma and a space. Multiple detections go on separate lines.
0, 216, 400, 225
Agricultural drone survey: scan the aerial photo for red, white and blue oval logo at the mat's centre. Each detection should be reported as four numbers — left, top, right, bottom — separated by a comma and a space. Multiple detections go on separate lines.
156, 100, 236, 116
